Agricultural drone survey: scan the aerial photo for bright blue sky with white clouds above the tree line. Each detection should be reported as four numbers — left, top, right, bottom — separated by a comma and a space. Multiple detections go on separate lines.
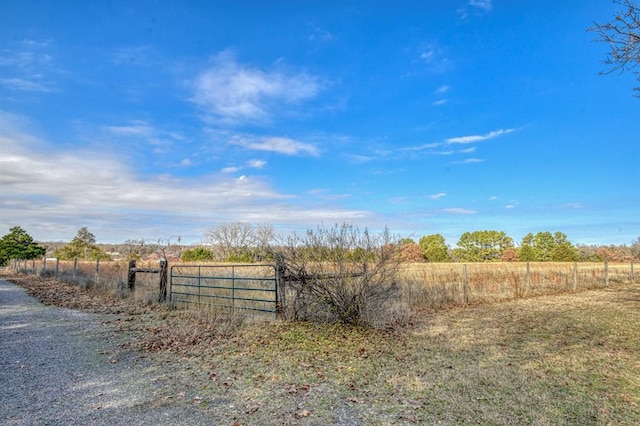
0, 0, 640, 246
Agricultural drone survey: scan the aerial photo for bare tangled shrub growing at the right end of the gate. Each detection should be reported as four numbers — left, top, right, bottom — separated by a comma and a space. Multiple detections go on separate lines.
273, 224, 401, 327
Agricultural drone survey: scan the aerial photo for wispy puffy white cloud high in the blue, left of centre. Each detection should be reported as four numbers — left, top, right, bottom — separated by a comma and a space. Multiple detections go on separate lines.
192, 51, 320, 124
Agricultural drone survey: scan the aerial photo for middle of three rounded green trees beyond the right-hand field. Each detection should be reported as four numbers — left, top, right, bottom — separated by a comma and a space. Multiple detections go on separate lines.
453, 231, 513, 262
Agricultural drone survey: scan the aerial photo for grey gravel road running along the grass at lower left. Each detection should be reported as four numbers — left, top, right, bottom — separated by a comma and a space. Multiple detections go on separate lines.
0, 280, 215, 426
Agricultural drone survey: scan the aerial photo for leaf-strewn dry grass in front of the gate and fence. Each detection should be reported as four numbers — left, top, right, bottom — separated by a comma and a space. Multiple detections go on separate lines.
2, 264, 640, 425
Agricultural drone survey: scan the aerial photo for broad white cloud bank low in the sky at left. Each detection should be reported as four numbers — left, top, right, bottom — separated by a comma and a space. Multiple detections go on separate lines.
0, 112, 370, 242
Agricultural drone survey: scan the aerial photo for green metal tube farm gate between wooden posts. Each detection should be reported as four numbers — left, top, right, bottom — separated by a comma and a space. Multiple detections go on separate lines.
169, 265, 278, 314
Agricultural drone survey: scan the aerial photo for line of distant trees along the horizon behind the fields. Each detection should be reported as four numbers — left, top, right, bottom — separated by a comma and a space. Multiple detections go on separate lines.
0, 222, 640, 266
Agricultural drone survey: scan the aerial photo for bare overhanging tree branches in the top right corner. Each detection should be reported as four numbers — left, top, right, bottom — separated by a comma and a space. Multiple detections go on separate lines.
588, 0, 640, 96
